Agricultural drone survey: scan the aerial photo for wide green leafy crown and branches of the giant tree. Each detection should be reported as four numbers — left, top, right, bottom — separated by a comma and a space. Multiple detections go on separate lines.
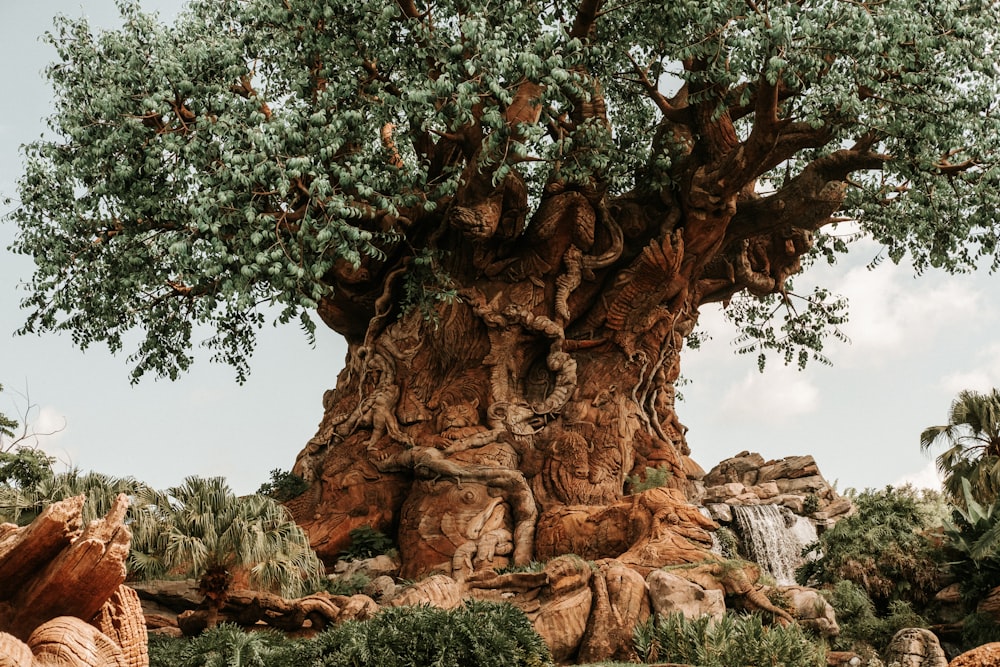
12, 0, 1000, 378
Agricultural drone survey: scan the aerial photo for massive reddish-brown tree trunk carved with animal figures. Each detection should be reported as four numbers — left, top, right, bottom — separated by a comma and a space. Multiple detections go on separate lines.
291, 188, 738, 577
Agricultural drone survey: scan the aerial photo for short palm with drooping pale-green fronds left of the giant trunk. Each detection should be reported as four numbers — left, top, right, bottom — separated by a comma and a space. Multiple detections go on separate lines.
129, 477, 323, 627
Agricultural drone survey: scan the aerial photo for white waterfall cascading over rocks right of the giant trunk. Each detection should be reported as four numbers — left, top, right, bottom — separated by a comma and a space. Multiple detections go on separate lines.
732, 505, 816, 585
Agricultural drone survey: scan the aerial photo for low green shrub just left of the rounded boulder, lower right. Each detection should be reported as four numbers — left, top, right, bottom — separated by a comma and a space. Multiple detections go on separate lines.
824, 579, 928, 653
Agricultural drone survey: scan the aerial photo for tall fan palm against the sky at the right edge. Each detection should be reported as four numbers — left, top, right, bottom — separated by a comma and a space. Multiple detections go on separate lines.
920, 389, 1000, 506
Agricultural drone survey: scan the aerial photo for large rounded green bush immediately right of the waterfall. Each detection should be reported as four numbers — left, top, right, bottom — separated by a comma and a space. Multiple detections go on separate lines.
796, 486, 942, 614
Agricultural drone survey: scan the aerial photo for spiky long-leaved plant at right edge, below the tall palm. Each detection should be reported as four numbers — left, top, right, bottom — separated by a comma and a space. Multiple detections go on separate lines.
945, 479, 1000, 608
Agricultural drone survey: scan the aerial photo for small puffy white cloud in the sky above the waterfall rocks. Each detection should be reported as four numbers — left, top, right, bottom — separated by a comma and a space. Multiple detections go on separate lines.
721, 365, 819, 424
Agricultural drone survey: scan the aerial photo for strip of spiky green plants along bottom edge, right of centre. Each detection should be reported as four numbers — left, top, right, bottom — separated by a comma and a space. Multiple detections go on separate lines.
633, 614, 826, 667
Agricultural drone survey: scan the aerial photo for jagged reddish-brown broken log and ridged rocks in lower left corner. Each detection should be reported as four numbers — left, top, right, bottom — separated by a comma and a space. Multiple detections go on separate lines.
0, 495, 149, 667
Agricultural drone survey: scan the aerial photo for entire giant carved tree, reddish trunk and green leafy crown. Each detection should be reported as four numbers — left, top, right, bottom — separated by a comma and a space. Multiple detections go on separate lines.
12, 0, 1000, 577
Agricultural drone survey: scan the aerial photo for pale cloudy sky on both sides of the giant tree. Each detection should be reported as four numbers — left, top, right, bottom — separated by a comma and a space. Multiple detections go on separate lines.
0, 0, 1000, 493
